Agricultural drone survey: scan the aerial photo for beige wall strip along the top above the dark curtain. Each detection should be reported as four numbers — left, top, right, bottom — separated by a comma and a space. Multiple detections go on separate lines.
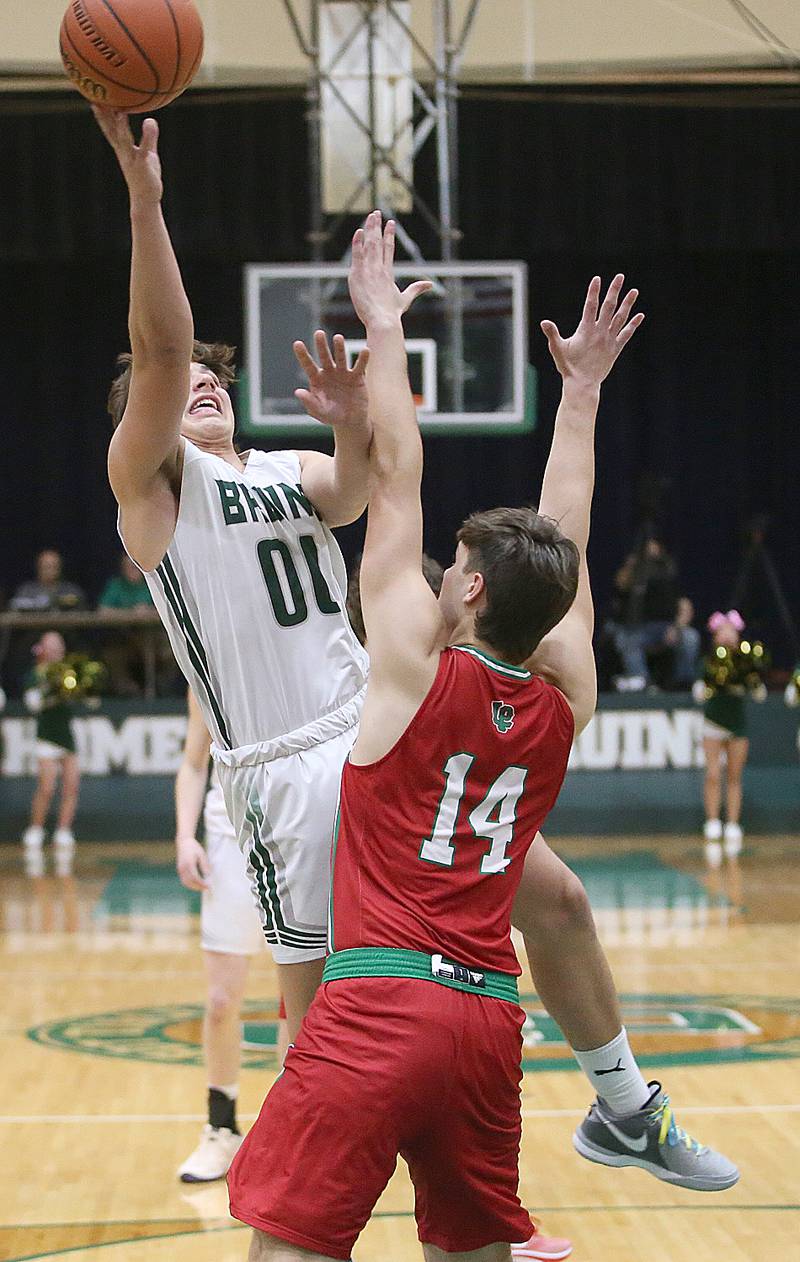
0, 0, 800, 86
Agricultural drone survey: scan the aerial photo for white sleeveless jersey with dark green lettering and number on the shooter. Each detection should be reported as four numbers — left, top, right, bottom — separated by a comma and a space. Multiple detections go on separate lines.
145, 440, 367, 750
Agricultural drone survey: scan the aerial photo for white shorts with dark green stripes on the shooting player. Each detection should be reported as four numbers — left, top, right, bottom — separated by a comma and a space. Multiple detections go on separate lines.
212, 689, 365, 964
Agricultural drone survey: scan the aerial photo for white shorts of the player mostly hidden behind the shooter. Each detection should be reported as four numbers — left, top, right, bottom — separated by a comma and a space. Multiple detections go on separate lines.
201, 777, 266, 955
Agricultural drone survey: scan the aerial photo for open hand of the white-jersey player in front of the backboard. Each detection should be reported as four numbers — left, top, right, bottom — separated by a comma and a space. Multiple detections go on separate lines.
294, 329, 370, 429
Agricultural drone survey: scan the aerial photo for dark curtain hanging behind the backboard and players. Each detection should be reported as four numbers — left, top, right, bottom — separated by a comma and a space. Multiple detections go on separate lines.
0, 88, 800, 661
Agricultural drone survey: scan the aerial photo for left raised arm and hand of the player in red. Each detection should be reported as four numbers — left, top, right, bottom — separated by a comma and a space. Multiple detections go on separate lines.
350, 211, 442, 711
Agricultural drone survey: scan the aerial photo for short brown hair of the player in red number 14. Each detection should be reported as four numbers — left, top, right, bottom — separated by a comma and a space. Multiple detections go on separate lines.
458, 509, 580, 665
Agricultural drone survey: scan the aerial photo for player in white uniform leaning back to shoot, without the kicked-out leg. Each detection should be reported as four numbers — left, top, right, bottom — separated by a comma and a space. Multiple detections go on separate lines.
95, 110, 393, 1039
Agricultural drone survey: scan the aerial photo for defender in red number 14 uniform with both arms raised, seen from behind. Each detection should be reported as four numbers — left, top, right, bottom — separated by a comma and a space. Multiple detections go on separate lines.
230, 216, 736, 1262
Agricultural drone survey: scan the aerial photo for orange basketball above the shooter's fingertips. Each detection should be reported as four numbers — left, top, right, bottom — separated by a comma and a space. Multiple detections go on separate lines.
59, 0, 203, 114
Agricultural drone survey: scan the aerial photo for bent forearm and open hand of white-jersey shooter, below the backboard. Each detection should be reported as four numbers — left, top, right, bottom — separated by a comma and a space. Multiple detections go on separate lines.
294, 329, 372, 526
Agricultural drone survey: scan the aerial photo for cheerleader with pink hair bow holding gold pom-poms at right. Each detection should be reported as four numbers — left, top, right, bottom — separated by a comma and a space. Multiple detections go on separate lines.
694, 610, 767, 867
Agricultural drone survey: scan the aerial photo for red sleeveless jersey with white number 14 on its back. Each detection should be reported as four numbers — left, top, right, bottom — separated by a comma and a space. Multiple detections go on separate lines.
329, 646, 574, 974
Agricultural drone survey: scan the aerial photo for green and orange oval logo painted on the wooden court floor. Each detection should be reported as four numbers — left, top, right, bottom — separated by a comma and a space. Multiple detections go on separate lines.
28, 994, 800, 1073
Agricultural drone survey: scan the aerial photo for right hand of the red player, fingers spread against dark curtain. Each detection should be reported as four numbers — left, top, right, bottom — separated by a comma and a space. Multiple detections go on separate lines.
541, 275, 645, 386
